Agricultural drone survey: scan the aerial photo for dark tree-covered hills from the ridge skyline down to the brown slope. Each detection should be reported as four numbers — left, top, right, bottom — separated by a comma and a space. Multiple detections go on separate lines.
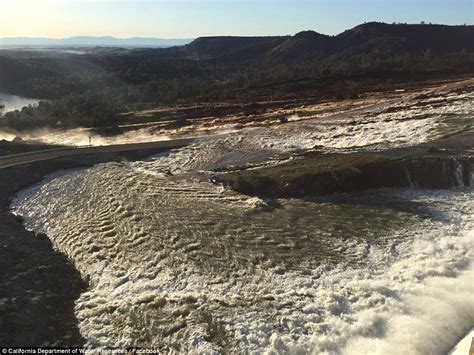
0, 23, 474, 129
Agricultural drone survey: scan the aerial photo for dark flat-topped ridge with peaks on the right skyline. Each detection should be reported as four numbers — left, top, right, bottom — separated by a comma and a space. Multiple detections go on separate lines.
175, 22, 474, 64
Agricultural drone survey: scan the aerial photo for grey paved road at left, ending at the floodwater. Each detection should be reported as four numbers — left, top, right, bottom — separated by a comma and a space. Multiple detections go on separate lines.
0, 138, 194, 169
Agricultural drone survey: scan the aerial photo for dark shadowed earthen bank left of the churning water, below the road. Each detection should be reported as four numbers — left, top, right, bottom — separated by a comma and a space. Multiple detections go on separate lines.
0, 142, 193, 346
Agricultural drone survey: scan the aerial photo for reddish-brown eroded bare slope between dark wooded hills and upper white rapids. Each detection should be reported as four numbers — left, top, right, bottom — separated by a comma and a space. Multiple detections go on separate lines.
112, 76, 474, 141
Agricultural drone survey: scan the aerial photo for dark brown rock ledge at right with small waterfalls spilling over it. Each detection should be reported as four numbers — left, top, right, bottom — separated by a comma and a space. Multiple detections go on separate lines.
218, 134, 474, 197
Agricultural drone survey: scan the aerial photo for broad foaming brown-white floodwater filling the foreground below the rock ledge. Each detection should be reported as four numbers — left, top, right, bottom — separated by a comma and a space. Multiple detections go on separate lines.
13, 159, 474, 355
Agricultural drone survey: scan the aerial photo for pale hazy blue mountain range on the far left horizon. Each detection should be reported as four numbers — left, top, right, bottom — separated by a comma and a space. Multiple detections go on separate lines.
0, 36, 192, 47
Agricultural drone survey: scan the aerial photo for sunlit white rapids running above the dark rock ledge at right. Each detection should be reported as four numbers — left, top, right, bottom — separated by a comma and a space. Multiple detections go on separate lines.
257, 92, 474, 151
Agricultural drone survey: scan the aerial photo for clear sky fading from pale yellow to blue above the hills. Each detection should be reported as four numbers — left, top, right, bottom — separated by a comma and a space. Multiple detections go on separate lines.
0, 0, 474, 38
